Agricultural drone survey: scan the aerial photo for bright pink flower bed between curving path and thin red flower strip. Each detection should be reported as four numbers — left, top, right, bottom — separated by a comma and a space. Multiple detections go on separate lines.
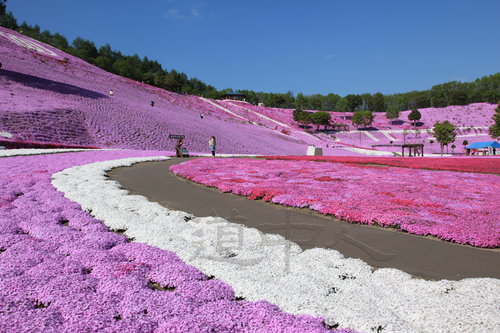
170, 158, 500, 247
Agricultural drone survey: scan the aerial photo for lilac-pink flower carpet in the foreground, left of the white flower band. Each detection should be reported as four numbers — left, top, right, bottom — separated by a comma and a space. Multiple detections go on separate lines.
0, 151, 351, 333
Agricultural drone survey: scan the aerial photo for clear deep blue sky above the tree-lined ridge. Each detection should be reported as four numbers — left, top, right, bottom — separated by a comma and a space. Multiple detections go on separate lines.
7, 0, 500, 95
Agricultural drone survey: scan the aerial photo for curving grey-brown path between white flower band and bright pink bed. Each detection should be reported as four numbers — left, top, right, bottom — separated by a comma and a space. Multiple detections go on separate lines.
108, 159, 500, 280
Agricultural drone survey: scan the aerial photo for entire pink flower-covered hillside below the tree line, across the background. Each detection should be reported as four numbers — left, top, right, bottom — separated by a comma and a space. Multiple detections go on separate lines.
0, 27, 495, 156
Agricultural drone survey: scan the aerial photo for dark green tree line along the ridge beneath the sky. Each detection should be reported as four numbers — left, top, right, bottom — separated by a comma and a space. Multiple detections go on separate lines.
0, 0, 500, 112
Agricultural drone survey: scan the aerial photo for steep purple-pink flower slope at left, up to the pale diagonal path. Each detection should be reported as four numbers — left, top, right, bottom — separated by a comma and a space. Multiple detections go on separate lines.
0, 27, 305, 154
